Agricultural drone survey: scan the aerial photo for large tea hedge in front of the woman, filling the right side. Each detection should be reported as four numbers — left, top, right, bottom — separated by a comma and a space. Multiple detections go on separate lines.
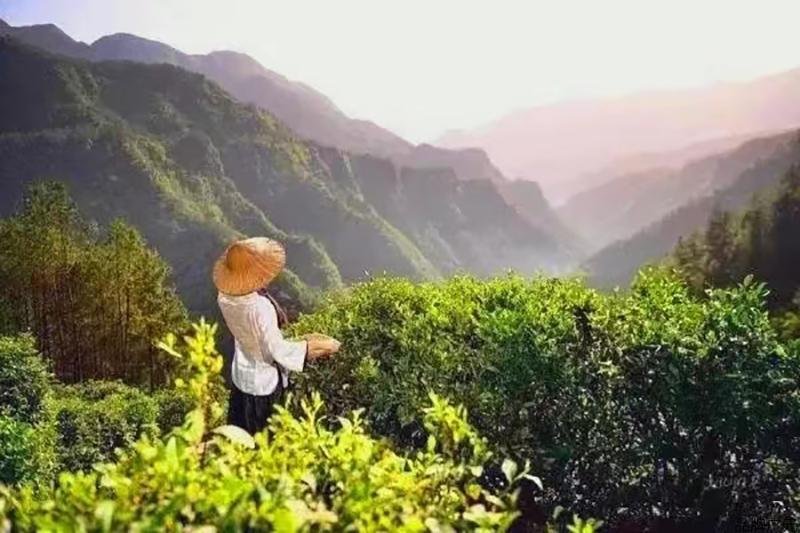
292, 271, 800, 528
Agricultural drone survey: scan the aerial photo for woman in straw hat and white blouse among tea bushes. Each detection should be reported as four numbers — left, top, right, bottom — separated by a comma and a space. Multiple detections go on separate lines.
214, 237, 339, 434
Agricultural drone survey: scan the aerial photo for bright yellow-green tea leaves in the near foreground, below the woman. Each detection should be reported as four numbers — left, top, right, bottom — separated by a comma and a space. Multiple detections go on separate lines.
0, 324, 527, 531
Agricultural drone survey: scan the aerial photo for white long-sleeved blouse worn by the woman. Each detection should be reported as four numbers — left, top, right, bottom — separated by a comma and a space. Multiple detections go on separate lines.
217, 292, 307, 396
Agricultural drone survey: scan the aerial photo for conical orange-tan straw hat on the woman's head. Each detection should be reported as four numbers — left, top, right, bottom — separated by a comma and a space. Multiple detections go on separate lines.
214, 237, 286, 296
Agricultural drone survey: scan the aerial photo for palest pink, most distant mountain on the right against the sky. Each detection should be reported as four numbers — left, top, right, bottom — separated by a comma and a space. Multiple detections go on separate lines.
434, 69, 800, 203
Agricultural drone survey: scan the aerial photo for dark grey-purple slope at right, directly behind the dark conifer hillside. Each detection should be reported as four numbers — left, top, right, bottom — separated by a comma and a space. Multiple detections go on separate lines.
584, 134, 800, 287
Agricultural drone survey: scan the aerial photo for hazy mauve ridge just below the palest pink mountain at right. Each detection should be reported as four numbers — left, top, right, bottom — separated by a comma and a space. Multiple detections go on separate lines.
558, 133, 794, 251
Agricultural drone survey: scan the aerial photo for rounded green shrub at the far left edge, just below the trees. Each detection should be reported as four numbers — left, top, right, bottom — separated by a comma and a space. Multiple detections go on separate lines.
0, 335, 51, 424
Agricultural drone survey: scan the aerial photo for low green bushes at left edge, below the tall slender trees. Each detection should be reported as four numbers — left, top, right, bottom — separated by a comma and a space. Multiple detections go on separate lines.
0, 336, 197, 486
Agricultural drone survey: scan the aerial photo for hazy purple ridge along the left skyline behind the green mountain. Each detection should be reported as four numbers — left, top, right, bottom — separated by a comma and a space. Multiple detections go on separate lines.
0, 20, 505, 187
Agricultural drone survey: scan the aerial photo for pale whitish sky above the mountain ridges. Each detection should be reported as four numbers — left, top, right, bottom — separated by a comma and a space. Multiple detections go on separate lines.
0, 0, 800, 142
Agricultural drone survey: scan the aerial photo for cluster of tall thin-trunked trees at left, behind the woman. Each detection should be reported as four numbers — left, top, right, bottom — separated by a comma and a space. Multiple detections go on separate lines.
0, 184, 185, 385
